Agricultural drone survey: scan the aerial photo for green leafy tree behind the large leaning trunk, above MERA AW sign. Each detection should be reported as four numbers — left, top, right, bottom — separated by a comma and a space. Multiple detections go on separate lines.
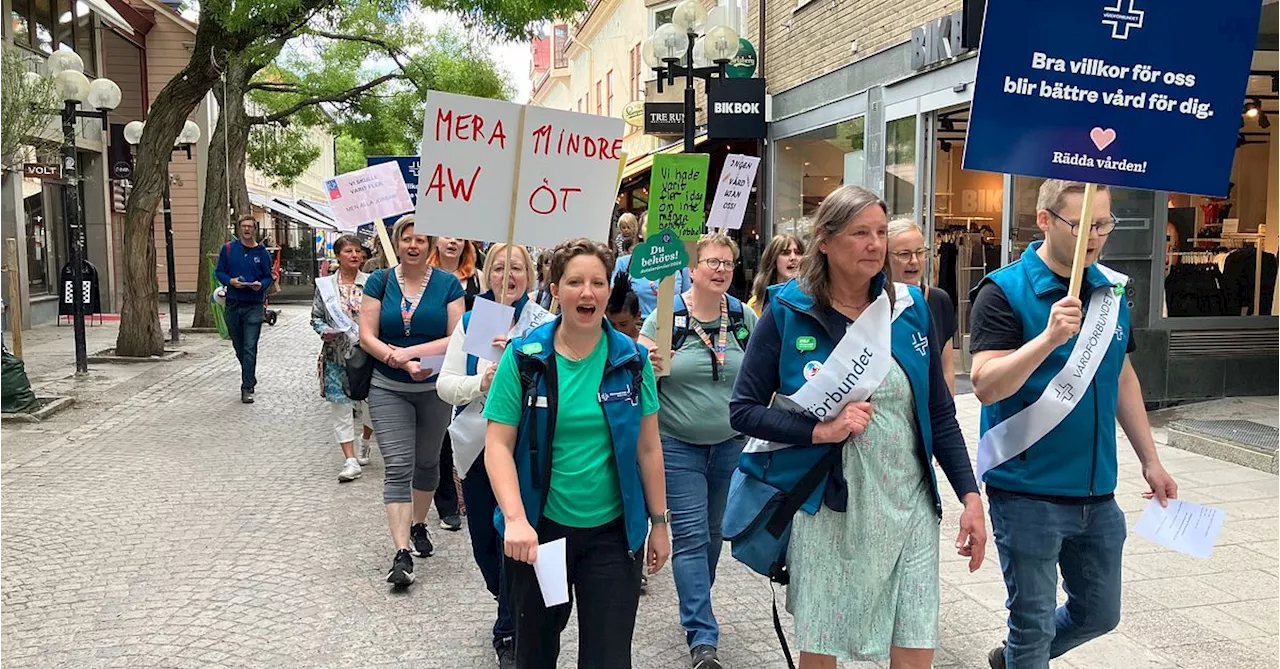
186, 1, 509, 327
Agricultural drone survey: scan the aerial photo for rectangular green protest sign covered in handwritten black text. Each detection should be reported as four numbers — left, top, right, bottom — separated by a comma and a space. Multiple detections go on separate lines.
649, 153, 712, 240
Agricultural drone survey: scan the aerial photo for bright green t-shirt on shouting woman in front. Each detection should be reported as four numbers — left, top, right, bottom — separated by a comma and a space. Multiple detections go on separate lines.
484, 336, 658, 528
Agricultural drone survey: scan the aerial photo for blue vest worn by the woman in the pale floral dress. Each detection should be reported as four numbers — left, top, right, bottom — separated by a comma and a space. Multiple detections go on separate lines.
739, 275, 942, 517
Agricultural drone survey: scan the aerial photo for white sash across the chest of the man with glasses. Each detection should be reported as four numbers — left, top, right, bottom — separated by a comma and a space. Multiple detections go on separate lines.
978, 265, 1128, 481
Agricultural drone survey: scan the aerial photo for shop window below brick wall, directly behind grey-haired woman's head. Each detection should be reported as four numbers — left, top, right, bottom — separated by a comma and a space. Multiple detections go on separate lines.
773, 118, 867, 237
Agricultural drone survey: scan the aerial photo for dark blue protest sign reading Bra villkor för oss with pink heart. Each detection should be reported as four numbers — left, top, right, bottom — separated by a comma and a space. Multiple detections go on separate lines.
964, 0, 1261, 196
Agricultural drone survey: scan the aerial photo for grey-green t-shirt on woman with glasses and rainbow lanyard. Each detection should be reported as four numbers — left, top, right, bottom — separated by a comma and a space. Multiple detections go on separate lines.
640, 308, 759, 446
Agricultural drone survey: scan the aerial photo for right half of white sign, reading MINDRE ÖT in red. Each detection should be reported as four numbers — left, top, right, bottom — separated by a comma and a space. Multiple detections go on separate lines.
516, 106, 625, 247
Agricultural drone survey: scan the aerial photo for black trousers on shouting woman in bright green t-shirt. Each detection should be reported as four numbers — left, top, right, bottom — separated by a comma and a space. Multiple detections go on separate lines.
507, 518, 644, 669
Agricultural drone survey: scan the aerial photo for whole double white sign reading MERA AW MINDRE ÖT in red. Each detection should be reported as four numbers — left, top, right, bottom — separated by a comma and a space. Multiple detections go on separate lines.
416, 91, 625, 247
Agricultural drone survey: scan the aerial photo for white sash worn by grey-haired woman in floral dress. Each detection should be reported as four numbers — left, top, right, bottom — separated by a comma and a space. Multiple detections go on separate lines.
742, 284, 915, 453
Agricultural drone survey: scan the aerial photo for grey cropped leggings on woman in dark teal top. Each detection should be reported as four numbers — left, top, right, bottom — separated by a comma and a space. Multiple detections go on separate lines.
369, 386, 452, 504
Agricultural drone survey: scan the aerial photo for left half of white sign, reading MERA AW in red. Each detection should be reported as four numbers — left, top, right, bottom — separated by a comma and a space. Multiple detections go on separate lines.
416, 91, 521, 242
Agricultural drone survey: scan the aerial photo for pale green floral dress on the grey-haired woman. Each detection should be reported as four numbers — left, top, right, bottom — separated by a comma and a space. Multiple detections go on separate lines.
787, 365, 940, 661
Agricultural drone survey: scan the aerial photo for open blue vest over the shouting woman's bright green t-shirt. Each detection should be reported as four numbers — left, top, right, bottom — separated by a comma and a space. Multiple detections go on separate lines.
494, 316, 649, 554
